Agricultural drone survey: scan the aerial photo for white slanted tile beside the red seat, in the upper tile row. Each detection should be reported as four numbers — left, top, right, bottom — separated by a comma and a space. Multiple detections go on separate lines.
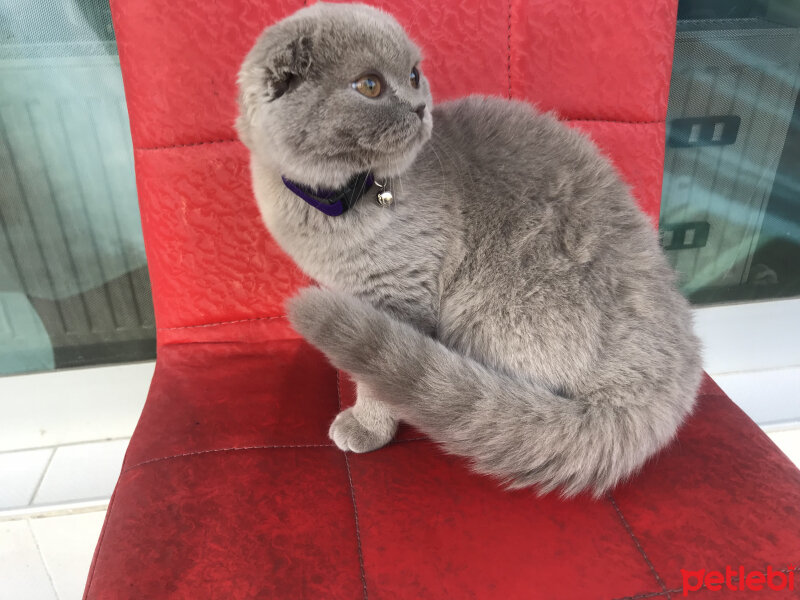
34, 439, 129, 505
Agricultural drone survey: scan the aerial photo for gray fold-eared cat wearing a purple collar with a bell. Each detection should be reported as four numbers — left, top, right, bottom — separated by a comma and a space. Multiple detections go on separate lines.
236, 3, 701, 495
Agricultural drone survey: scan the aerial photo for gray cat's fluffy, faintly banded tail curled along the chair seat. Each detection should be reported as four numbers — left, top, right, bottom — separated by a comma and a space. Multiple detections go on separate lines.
289, 288, 691, 496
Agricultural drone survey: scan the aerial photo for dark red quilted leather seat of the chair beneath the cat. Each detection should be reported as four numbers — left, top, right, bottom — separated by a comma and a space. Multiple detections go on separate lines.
86, 319, 800, 600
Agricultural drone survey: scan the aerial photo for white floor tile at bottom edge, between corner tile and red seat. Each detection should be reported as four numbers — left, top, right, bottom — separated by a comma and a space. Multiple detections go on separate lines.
30, 510, 106, 600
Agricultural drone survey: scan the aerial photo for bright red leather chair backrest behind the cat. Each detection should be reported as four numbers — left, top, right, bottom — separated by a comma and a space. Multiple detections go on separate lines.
112, 0, 677, 343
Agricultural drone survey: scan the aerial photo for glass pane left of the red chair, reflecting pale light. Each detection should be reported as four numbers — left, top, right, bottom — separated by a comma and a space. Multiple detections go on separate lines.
0, 0, 155, 374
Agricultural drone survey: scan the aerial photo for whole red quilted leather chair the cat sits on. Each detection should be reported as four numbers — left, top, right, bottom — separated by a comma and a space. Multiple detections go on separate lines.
85, 0, 800, 600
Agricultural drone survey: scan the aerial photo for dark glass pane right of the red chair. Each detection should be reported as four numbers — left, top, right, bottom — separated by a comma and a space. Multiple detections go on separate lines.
660, 0, 800, 304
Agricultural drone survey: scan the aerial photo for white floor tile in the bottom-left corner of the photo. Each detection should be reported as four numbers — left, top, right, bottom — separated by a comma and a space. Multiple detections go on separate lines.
0, 521, 57, 600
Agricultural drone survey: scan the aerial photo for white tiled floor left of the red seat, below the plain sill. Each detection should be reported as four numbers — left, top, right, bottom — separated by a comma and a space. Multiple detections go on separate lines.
0, 438, 129, 600
